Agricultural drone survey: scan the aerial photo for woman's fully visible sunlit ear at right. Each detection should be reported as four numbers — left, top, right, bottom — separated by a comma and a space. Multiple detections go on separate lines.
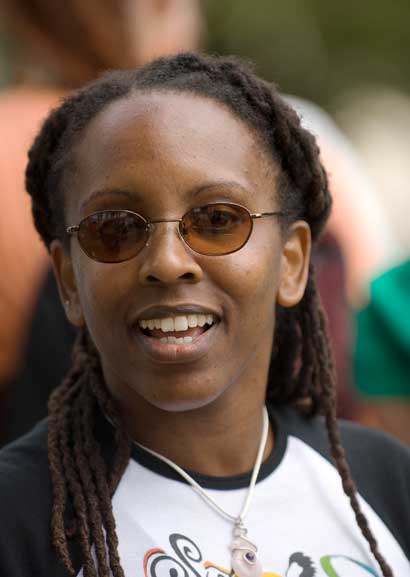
276, 220, 312, 307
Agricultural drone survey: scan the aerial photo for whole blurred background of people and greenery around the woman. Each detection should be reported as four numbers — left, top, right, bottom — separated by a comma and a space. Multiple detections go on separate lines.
0, 0, 410, 445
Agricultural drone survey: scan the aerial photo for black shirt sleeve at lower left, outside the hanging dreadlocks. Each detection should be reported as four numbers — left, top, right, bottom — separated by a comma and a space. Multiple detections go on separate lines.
0, 421, 81, 577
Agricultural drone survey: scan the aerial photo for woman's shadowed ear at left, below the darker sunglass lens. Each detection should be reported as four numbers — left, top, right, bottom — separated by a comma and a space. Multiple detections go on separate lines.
50, 240, 85, 327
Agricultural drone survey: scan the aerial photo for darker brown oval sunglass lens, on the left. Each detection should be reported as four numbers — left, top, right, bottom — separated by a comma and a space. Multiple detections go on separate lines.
78, 210, 147, 262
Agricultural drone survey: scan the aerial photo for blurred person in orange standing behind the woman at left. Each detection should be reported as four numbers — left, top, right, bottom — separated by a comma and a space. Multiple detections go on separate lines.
0, 0, 203, 442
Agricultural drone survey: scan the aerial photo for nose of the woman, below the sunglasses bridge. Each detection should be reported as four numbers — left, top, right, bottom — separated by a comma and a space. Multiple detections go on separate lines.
139, 222, 203, 285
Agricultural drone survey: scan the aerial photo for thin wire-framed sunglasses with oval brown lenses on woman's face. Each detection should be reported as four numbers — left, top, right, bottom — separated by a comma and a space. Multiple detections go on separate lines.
66, 202, 286, 263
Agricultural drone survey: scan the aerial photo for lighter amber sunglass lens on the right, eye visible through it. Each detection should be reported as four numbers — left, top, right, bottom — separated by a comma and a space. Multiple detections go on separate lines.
180, 203, 252, 255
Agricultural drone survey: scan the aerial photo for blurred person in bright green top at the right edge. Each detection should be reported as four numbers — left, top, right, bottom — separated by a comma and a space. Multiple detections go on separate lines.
354, 260, 410, 445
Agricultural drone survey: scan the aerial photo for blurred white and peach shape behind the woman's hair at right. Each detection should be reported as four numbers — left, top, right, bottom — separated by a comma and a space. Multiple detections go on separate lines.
287, 96, 400, 309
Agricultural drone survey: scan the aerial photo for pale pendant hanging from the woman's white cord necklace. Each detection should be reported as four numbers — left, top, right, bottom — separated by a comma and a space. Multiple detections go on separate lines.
231, 520, 263, 577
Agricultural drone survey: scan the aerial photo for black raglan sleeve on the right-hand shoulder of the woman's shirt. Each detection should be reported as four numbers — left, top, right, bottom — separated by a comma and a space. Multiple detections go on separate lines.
273, 409, 410, 551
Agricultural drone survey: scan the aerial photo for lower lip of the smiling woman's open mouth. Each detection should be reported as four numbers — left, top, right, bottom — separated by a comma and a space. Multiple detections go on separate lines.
133, 318, 221, 364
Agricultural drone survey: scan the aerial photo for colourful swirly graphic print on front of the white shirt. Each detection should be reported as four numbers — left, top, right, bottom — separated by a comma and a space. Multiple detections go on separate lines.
143, 533, 379, 577
